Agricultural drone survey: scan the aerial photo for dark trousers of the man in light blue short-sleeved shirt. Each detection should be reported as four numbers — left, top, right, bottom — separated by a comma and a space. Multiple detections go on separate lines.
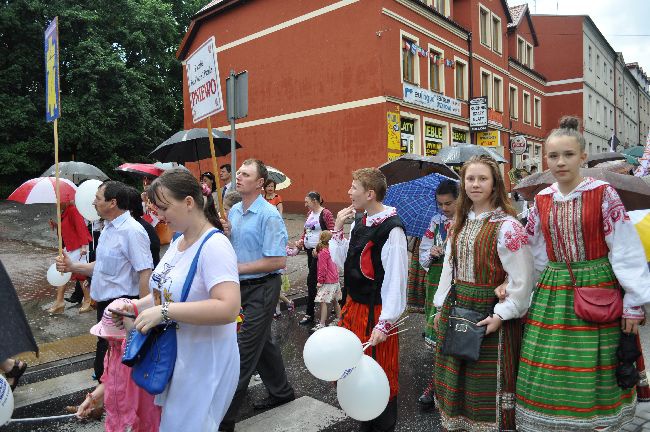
221, 275, 293, 426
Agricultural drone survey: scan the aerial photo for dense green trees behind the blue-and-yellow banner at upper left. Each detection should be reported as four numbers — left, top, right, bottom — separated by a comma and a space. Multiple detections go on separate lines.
0, 0, 207, 192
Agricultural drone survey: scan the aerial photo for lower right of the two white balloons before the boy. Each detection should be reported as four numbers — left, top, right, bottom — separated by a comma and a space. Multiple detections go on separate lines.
336, 355, 390, 421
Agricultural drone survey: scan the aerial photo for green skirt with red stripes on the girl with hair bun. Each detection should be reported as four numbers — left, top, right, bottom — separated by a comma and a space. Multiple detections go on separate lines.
516, 257, 636, 432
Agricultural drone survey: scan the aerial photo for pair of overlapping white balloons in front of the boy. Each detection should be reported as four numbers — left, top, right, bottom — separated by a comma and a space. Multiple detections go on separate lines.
303, 327, 390, 421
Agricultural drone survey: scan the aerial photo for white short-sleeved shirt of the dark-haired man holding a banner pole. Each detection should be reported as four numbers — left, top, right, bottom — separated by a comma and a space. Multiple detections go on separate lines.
90, 211, 153, 301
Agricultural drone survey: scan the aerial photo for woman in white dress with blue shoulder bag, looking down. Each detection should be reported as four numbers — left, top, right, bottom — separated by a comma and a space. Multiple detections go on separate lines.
116, 170, 240, 432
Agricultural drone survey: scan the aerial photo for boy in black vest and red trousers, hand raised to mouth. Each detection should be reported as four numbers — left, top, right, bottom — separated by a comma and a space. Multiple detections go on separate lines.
330, 168, 408, 432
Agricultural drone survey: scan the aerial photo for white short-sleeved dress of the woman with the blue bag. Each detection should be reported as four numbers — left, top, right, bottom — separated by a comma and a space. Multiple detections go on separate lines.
149, 232, 239, 432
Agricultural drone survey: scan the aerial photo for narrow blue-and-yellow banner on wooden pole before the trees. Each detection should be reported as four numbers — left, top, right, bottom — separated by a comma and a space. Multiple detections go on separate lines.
44, 17, 61, 123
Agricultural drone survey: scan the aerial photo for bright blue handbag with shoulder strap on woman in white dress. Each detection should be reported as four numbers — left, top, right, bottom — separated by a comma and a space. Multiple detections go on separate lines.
122, 229, 221, 395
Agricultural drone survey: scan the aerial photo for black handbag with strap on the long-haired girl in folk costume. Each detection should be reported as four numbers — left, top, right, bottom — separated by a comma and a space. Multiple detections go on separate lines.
440, 262, 487, 361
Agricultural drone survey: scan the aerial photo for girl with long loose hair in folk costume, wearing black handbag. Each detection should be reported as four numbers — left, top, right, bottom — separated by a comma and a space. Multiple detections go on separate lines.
434, 156, 533, 431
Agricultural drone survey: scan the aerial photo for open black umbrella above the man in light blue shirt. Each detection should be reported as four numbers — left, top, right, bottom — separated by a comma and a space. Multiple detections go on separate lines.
149, 128, 241, 163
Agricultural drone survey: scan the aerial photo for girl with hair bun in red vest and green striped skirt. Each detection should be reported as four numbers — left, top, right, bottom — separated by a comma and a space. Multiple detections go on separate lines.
517, 117, 650, 431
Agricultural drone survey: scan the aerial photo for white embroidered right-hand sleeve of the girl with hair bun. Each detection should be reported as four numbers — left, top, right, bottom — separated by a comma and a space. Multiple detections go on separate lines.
602, 185, 650, 308
